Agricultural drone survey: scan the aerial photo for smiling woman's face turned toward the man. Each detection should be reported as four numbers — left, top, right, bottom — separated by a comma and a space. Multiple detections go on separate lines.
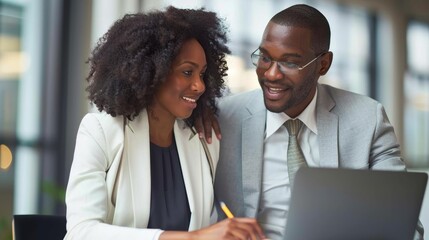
152, 39, 207, 119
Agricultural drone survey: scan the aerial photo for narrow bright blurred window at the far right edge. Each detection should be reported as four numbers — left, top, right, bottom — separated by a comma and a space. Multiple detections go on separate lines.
404, 21, 429, 167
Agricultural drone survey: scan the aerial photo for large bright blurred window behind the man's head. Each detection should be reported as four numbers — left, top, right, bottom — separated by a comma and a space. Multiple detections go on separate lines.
190, 0, 374, 97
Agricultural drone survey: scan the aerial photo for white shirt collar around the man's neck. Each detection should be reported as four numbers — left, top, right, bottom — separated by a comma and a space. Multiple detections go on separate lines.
265, 89, 317, 139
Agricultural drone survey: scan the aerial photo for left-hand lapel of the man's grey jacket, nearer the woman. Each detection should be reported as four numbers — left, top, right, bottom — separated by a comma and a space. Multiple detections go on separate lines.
242, 96, 266, 217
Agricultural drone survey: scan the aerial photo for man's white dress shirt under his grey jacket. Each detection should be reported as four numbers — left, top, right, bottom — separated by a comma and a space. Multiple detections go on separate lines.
257, 91, 320, 239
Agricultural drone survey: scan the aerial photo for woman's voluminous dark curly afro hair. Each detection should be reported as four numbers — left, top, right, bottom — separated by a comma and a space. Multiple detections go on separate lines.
86, 6, 230, 125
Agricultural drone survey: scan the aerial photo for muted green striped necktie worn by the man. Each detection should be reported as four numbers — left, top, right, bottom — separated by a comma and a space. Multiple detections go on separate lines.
285, 119, 307, 188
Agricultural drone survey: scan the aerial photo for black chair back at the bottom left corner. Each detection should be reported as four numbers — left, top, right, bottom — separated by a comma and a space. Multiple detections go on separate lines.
12, 214, 66, 240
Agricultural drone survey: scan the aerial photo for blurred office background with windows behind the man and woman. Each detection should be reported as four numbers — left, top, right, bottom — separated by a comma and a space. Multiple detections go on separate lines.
0, 0, 429, 239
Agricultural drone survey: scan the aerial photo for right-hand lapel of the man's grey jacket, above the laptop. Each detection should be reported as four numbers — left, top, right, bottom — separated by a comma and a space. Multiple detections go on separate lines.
316, 85, 339, 168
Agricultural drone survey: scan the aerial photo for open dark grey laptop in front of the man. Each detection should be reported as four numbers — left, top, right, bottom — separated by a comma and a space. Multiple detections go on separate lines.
285, 168, 429, 240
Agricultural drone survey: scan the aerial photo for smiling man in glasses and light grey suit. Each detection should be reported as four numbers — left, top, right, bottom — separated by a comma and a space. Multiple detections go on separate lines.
201, 5, 423, 239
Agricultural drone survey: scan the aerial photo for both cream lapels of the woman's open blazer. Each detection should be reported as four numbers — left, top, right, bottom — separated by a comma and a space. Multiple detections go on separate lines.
124, 110, 207, 229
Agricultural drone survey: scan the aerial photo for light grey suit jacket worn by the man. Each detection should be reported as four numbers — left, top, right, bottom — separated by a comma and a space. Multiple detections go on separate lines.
215, 85, 422, 238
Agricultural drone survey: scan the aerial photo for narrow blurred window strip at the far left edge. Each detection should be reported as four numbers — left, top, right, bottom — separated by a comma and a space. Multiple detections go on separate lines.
0, 2, 24, 239
